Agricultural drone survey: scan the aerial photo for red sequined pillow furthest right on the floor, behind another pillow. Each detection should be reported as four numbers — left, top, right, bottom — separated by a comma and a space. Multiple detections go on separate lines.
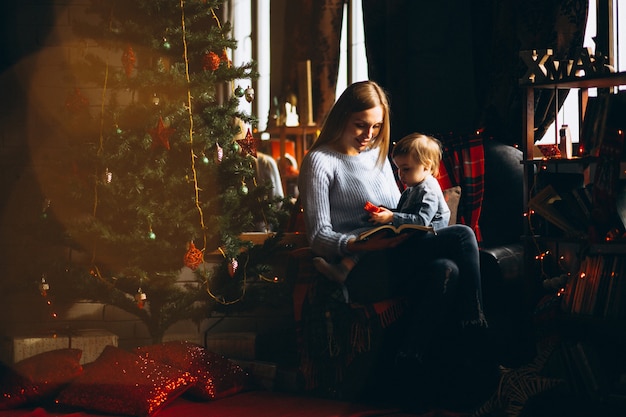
137, 341, 249, 400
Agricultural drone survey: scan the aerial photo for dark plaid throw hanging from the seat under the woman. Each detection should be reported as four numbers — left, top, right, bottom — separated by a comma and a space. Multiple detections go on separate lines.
287, 248, 406, 393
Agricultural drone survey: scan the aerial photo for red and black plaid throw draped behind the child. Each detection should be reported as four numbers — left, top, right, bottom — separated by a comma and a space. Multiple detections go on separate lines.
439, 132, 485, 242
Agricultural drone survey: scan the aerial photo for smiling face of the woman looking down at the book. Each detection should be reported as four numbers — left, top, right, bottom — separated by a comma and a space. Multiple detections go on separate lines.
337, 106, 384, 155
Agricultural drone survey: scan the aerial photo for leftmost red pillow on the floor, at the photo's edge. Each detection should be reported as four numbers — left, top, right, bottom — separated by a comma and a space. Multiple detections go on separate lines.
0, 349, 83, 410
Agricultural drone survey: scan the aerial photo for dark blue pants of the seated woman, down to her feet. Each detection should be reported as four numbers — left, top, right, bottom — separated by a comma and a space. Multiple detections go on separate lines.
346, 225, 484, 406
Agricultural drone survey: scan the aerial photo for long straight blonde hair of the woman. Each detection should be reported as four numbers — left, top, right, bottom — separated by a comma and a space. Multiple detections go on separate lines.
310, 81, 390, 165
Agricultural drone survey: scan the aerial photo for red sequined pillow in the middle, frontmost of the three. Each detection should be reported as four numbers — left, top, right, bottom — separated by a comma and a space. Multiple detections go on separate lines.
57, 345, 196, 417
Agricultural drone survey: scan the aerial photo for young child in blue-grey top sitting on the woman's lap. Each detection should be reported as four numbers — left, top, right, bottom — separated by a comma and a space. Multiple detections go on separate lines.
313, 133, 450, 290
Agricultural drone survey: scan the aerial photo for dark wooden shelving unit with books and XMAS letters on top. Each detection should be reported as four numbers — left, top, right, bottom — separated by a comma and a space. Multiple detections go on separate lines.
522, 72, 626, 415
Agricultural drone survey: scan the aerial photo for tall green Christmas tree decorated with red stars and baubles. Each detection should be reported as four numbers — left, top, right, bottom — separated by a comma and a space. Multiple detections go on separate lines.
33, 0, 286, 342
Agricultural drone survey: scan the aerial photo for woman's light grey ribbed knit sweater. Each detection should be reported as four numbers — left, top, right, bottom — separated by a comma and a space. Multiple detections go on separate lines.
298, 146, 400, 259
